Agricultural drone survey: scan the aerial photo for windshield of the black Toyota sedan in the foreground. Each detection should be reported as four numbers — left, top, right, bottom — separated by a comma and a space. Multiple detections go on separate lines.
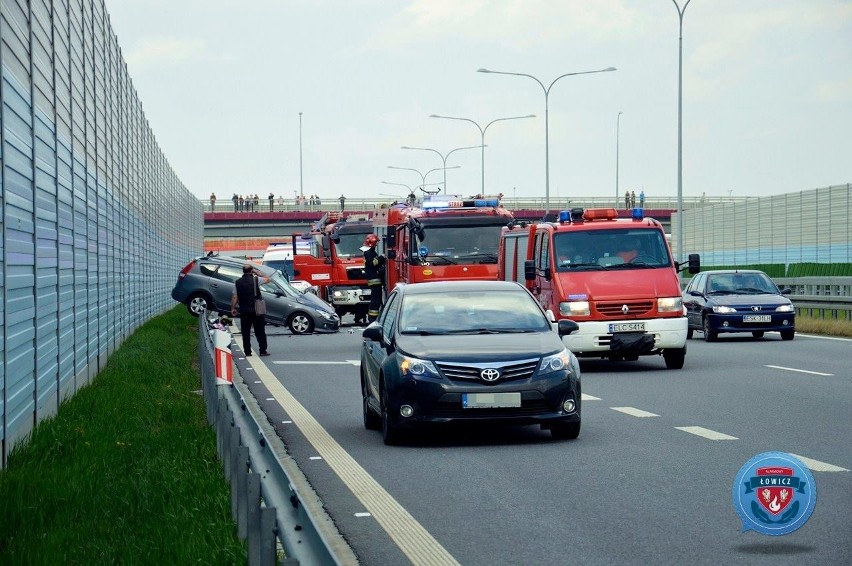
399, 289, 551, 334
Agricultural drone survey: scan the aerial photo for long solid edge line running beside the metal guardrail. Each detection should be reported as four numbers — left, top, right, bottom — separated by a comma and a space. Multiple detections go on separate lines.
250, 360, 459, 566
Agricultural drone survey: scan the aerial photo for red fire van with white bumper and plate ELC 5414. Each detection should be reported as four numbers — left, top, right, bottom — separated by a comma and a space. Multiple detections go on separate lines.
499, 208, 701, 369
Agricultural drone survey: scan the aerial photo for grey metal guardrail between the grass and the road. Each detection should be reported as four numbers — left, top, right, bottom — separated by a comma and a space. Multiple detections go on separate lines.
198, 316, 356, 566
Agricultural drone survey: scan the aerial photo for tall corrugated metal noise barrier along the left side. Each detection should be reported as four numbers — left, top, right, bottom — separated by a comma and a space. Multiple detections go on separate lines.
0, 0, 203, 465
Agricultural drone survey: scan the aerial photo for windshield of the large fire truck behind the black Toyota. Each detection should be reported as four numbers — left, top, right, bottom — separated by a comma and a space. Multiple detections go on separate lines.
411, 224, 501, 265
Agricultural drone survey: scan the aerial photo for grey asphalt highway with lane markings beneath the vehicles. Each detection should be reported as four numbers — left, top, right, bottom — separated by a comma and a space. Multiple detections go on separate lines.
235, 326, 852, 566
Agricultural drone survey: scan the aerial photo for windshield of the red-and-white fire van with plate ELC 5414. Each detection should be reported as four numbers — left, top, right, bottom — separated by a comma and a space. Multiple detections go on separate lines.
553, 229, 672, 271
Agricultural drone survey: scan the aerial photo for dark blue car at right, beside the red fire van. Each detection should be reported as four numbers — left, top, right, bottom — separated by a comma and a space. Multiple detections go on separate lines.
683, 269, 796, 342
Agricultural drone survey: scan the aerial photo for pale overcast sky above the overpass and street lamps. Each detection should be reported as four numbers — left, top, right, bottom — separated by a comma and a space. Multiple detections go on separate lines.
106, 0, 852, 204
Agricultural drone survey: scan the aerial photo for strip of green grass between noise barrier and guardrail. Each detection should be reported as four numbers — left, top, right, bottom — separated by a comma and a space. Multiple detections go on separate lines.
0, 307, 246, 565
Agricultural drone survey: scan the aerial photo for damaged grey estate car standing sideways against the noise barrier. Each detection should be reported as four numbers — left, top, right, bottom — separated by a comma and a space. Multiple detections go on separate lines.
172, 256, 340, 334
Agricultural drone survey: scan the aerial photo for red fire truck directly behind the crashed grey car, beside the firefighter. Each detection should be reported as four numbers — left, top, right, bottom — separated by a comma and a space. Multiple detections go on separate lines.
293, 212, 373, 320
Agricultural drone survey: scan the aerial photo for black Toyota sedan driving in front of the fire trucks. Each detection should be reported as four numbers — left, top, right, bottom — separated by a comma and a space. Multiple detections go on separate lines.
361, 281, 580, 444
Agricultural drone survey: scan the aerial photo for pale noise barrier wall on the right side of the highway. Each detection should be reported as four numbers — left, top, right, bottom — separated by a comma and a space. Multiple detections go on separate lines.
672, 185, 852, 266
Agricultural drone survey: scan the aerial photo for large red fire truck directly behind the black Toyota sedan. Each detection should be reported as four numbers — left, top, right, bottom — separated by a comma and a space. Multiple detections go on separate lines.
373, 195, 513, 291
